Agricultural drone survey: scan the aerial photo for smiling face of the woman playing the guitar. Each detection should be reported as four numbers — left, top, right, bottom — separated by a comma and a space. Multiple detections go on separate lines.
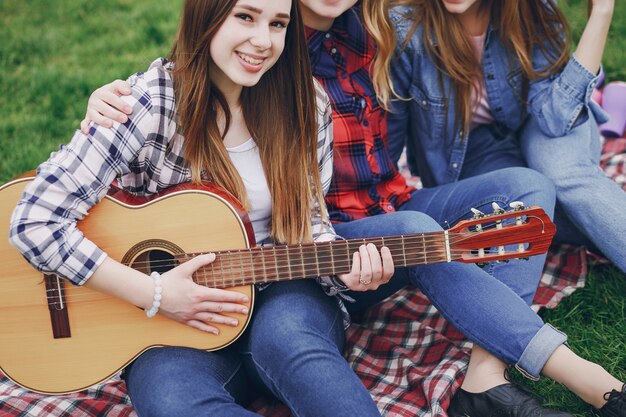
210, 0, 291, 96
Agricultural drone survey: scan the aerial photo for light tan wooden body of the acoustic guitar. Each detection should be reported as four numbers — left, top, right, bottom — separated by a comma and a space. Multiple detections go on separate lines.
0, 178, 254, 394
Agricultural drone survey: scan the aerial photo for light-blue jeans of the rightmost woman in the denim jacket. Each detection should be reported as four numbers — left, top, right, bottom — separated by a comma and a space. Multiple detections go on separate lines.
520, 115, 626, 272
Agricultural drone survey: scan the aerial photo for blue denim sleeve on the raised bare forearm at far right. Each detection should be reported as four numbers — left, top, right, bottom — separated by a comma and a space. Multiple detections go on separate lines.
528, 48, 604, 137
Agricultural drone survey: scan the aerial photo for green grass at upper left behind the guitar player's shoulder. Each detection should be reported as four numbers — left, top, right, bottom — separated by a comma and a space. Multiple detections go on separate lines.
0, 0, 182, 183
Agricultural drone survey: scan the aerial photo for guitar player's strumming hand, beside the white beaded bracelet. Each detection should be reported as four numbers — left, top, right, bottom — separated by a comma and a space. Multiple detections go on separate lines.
159, 253, 249, 334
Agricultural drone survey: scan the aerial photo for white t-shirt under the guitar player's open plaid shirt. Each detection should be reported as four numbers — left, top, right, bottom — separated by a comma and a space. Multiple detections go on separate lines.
226, 138, 272, 242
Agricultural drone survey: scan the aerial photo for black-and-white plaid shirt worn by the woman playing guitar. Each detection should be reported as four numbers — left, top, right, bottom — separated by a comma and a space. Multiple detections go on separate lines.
10, 59, 336, 286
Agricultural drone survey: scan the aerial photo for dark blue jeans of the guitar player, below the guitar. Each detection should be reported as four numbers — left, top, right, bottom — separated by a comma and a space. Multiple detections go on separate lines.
124, 280, 380, 417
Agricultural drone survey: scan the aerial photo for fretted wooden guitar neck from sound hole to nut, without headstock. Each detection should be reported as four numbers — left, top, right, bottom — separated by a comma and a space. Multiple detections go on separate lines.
184, 232, 453, 288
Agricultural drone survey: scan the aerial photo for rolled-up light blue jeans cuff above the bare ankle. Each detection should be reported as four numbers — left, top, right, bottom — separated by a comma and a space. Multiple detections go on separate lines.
515, 323, 567, 381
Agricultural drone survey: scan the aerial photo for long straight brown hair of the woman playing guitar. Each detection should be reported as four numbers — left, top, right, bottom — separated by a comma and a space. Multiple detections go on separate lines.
169, 0, 325, 243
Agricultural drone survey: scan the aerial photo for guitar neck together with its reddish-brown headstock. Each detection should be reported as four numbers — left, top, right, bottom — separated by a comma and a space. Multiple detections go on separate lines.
177, 202, 556, 288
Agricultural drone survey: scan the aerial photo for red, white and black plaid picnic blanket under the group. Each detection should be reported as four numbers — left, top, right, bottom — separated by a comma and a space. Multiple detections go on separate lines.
0, 137, 626, 417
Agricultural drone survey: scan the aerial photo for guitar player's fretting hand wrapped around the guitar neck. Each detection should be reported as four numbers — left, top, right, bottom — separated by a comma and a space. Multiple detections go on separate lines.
339, 243, 394, 291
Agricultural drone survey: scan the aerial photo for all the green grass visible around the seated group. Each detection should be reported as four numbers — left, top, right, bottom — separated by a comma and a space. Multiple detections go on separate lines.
0, 0, 626, 416
